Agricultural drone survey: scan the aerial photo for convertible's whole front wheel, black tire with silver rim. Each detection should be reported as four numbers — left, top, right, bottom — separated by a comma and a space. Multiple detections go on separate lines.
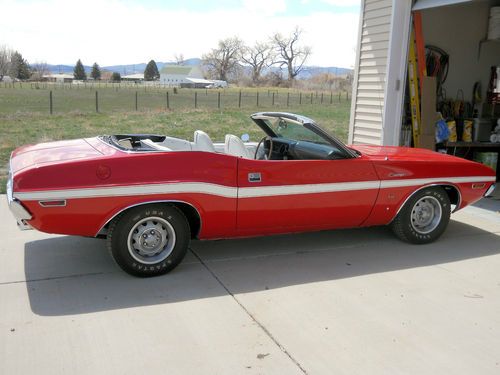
391, 187, 451, 244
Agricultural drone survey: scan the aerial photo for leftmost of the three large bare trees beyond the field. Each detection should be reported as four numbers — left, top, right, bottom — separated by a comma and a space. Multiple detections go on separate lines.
203, 37, 243, 81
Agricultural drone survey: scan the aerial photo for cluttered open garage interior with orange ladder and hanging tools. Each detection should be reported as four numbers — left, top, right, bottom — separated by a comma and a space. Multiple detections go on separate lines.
401, 0, 500, 181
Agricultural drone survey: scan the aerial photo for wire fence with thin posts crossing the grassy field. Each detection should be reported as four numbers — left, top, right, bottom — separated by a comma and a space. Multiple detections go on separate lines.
0, 82, 350, 114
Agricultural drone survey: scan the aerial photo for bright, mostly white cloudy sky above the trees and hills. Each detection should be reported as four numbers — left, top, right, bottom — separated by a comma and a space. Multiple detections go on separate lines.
0, 0, 360, 68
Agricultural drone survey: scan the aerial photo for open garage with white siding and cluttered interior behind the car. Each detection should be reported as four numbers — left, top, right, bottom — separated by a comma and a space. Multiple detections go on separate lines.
349, 0, 500, 180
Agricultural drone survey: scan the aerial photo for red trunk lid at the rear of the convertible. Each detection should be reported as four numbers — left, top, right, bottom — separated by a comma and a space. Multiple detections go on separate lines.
10, 139, 102, 173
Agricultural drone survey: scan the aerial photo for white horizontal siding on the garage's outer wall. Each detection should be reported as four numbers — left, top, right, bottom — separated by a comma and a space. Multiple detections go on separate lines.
349, 0, 393, 145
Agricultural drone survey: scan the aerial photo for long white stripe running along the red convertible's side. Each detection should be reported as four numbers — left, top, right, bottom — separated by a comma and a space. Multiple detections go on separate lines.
14, 176, 495, 201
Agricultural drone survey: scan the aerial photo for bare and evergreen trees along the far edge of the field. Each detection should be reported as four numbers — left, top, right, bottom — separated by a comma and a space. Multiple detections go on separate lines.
0, 27, 311, 86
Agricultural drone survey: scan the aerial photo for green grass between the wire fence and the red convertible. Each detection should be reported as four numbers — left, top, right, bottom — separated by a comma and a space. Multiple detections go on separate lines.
0, 88, 350, 193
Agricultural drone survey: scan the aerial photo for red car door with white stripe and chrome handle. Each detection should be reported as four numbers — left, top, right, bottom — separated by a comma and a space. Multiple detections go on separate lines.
237, 156, 380, 235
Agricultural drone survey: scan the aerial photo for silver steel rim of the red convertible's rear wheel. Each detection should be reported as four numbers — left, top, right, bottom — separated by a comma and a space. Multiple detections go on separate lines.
127, 216, 175, 264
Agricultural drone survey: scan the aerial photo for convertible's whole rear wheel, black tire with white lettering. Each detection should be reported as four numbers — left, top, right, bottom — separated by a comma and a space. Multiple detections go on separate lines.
107, 204, 191, 277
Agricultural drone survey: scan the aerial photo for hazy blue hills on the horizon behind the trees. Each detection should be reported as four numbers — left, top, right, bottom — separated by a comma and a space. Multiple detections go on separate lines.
48, 58, 352, 79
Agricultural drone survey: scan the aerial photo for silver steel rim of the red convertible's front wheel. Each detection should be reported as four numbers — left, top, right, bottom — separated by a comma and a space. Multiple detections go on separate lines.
411, 196, 443, 234
